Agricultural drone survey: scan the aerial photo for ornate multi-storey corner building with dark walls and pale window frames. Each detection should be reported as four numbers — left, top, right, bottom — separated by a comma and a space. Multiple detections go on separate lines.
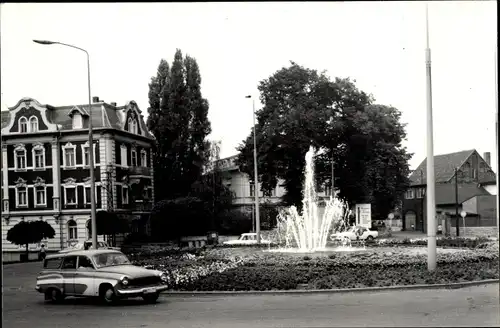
1, 97, 154, 253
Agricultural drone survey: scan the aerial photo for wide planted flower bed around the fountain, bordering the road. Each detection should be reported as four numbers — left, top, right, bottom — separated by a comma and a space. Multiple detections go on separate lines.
133, 242, 499, 291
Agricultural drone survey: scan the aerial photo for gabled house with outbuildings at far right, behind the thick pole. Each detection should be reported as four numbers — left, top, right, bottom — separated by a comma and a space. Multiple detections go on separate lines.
403, 149, 498, 232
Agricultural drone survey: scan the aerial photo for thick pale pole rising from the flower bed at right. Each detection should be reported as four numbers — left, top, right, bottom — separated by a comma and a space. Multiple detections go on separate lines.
425, 4, 436, 271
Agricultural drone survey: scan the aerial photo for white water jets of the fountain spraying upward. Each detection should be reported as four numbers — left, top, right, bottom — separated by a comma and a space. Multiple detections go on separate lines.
273, 146, 356, 253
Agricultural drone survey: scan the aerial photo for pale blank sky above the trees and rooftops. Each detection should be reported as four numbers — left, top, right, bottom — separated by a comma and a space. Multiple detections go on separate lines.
0, 1, 497, 169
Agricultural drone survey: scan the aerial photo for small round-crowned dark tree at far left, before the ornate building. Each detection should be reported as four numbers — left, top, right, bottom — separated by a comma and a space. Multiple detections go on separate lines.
7, 220, 56, 252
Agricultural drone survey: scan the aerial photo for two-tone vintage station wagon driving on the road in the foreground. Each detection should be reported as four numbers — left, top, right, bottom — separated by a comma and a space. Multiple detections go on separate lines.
35, 249, 168, 303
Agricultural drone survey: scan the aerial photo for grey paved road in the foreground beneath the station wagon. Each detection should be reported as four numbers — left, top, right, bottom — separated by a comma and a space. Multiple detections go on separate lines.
3, 263, 500, 328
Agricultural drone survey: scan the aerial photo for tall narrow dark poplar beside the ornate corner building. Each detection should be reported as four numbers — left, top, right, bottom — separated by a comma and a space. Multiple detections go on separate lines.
148, 49, 211, 200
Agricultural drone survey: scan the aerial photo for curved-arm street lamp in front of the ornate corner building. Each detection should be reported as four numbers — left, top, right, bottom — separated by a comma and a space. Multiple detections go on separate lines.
33, 40, 97, 249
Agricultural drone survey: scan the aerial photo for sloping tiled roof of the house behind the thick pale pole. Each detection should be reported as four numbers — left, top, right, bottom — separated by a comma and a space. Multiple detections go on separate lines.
410, 149, 476, 185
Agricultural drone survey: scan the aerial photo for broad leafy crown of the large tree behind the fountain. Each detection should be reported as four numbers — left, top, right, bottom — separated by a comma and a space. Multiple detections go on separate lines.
238, 62, 411, 220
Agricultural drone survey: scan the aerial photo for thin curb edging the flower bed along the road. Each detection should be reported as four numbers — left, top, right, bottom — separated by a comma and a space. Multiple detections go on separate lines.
162, 279, 500, 296
